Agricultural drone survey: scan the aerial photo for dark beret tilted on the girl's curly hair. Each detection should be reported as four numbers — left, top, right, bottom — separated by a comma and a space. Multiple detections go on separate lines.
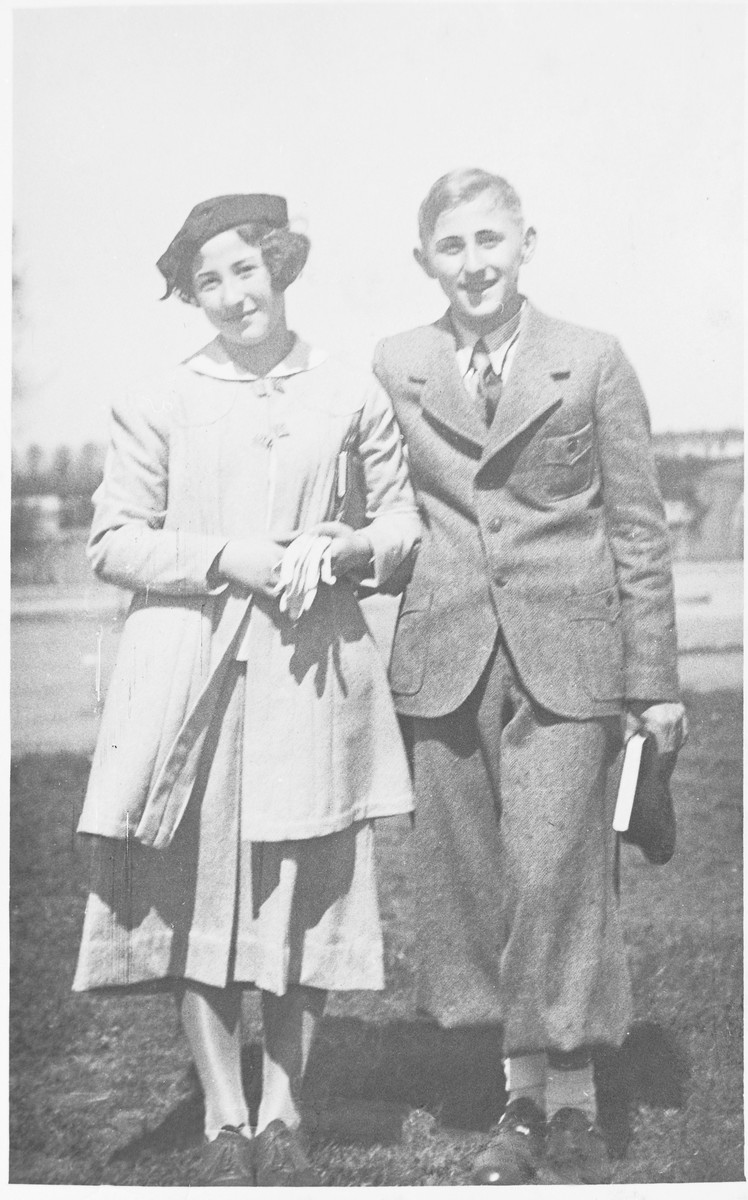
156, 192, 288, 296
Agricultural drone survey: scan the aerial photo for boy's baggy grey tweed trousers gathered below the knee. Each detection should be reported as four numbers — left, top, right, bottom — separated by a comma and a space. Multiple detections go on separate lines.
403, 638, 632, 1055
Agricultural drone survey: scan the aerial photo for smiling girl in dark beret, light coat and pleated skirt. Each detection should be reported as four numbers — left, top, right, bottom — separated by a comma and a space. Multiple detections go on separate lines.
73, 194, 419, 1186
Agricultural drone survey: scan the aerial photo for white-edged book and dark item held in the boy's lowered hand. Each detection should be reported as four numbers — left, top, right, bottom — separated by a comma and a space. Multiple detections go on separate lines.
614, 733, 677, 865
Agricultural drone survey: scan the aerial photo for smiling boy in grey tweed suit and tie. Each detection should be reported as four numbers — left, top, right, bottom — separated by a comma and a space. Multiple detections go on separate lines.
375, 169, 686, 1184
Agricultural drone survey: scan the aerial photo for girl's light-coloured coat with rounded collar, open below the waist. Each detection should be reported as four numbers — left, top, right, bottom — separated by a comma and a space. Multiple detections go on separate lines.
79, 341, 420, 847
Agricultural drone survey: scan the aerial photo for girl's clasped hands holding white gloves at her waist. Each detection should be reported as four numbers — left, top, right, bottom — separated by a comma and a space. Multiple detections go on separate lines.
216, 521, 372, 609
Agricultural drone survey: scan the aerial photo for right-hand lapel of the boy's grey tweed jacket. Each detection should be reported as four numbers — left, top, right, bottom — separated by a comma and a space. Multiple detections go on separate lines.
481, 305, 572, 467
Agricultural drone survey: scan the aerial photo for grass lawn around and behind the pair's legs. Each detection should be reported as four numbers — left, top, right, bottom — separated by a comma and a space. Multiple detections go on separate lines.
10, 691, 743, 1187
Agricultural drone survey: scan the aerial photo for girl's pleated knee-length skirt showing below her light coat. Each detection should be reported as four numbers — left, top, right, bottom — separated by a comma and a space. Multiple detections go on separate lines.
73, 664, 384, 996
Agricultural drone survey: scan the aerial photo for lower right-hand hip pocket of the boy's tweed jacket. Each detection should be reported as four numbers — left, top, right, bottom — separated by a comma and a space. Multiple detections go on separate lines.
569, 587, 624, 700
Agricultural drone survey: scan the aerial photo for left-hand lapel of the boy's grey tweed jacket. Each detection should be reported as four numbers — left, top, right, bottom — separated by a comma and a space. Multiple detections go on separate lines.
409, 317, 489, 449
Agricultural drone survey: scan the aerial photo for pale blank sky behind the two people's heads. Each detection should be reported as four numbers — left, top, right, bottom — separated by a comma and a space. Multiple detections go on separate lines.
12, 0, 746, 450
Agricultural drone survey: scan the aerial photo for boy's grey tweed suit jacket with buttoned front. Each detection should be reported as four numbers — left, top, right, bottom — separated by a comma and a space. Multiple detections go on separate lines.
375, 305, 678, 719
